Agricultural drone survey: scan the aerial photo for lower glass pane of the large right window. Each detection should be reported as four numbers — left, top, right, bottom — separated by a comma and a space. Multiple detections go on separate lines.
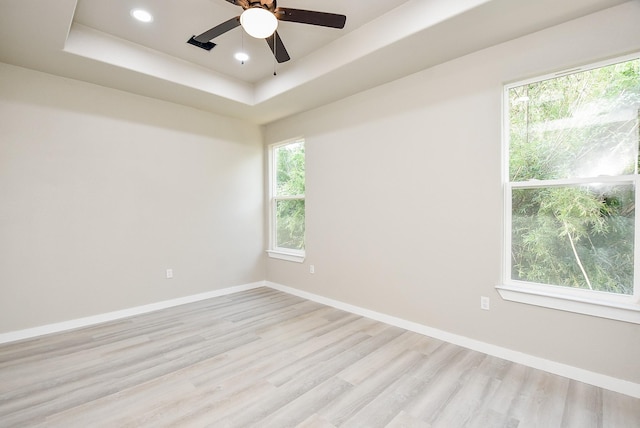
511, 184, 635, 294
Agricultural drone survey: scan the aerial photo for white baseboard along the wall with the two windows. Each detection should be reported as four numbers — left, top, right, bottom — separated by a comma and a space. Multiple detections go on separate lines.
265, 281, 640, 398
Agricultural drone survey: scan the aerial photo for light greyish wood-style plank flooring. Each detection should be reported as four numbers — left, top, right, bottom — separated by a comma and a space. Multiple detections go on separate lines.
0, 288, 640, 428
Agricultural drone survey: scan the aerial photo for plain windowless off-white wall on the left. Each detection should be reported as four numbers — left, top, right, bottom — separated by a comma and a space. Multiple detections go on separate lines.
0, 64, 265, 333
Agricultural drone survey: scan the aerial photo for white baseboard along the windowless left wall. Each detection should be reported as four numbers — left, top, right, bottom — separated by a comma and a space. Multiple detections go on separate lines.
0, 281, 265, 344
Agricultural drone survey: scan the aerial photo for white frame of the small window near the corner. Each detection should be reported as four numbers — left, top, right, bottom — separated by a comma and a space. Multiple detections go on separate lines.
267, 137, 306, 263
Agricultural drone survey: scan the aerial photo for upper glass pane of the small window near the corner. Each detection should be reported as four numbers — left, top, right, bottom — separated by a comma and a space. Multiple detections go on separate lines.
274, 141, 304, 196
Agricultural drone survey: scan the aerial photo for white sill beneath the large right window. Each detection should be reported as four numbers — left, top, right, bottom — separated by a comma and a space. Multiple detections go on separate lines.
496, 285, 640, 324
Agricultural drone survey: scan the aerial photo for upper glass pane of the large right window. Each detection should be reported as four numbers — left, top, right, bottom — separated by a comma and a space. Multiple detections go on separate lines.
509, 59, 640, 181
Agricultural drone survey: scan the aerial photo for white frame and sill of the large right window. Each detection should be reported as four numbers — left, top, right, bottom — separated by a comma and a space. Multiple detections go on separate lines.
496, 53, 640, 324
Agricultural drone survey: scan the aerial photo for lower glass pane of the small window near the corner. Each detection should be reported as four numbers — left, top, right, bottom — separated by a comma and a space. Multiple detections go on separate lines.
276, 199, 304, 250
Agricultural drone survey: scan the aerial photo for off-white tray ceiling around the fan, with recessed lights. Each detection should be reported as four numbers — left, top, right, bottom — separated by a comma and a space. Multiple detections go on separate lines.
0, 0, 625, 124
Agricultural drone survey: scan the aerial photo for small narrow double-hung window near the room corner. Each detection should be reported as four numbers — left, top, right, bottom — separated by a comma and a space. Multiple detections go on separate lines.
269, 139, 305, 262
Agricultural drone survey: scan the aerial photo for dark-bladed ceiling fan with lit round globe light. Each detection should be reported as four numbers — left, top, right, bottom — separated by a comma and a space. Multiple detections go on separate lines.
187, 0, 347, 63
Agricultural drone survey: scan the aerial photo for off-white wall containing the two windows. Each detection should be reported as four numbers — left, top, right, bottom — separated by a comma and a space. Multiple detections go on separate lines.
265, 2, 640, 383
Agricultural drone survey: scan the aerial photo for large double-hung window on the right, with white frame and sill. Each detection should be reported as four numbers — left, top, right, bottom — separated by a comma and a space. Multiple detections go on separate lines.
497, 55, 640, 323
